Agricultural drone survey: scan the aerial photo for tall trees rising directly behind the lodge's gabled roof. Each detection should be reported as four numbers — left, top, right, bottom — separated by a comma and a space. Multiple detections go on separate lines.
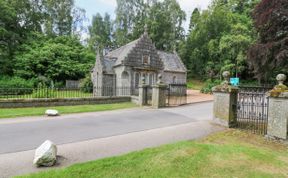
115, 0, 186, 51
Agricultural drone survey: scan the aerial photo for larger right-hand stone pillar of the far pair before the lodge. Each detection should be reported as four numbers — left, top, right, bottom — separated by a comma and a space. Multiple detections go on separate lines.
152, 74, 167, 109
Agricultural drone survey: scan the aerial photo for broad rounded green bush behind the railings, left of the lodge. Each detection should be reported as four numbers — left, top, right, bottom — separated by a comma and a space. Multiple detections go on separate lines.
14, 34, 94, 81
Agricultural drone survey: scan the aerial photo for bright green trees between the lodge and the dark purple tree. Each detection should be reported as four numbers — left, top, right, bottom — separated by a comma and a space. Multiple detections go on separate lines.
179, 0, 257, 79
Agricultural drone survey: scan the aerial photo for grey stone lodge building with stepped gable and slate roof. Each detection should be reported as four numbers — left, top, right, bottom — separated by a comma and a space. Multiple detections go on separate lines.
92, 29, 187, 96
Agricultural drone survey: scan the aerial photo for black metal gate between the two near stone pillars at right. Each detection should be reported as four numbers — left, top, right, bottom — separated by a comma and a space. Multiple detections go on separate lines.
237, 87, 271, 135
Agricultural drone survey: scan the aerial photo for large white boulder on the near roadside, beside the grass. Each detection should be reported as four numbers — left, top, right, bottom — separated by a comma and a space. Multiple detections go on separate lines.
33, 140, 57, 167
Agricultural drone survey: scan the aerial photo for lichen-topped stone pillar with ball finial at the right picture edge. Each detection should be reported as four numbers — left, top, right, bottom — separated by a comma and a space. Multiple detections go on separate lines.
267, 74, 288, 140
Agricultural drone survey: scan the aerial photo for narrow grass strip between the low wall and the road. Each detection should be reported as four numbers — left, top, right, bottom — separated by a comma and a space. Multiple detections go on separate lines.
0, 103, 136, 118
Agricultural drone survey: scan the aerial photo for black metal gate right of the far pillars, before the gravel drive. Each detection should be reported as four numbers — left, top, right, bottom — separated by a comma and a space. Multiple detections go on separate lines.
167, 84, 187, 106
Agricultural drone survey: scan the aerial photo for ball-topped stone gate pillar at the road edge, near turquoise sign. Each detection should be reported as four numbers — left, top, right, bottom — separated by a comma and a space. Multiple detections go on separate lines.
212, 71, 238, 127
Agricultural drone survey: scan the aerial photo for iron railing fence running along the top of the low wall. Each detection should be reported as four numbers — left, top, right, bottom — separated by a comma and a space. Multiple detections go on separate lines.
0, 86, 133, 100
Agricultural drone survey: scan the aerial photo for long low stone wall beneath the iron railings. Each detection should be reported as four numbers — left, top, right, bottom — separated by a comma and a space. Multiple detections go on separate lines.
0, 97, 131, 108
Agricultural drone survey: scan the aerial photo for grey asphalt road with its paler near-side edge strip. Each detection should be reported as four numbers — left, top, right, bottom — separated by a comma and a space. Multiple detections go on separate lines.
0, 102, 224, 178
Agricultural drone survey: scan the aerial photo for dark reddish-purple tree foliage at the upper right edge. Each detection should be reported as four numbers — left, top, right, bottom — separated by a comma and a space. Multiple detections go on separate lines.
249, 0, 288, 83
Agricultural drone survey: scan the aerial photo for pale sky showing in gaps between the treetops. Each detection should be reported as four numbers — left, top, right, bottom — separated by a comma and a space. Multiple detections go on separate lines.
76, 0, 211, 32
